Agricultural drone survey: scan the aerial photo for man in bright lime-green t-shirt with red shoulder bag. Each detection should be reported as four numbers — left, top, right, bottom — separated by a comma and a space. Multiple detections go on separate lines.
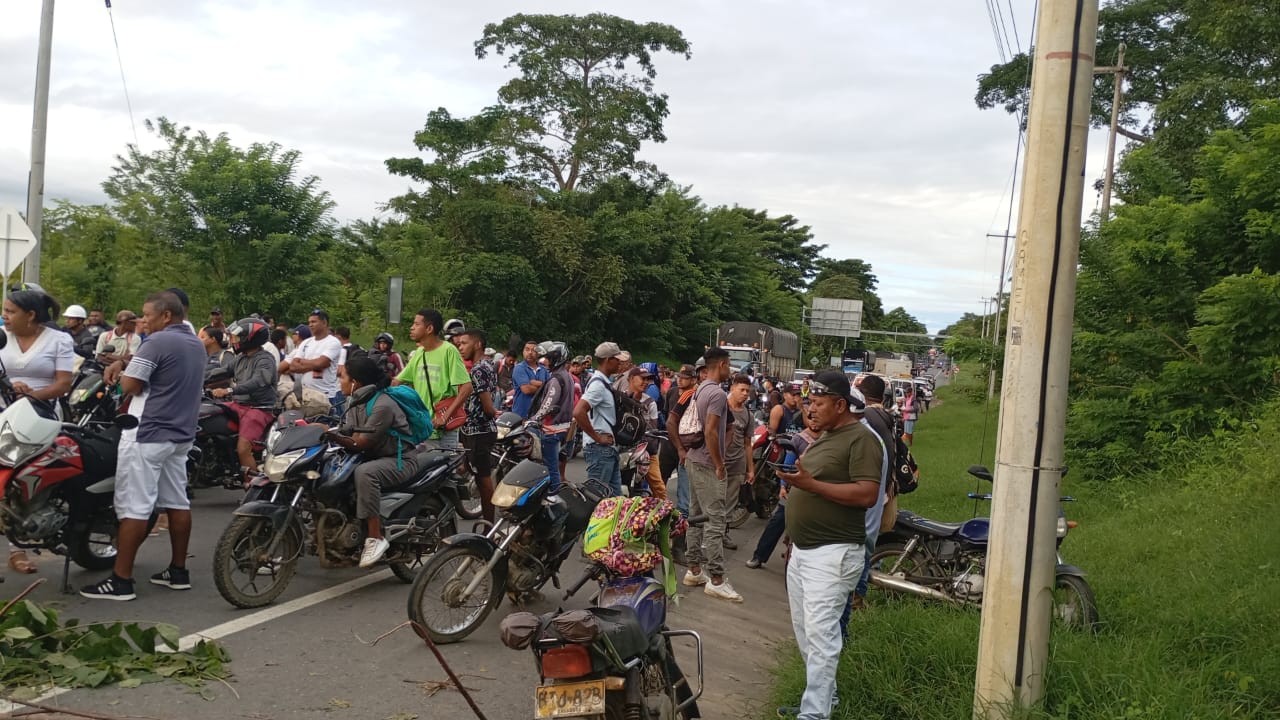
392, 309, 471, 447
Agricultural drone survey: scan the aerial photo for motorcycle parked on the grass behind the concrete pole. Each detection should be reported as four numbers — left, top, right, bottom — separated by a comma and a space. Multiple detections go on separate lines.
869, 465, 1098, 629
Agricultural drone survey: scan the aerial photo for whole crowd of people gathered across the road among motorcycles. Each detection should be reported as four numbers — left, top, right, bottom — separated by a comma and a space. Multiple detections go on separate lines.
0, 288, 922, 719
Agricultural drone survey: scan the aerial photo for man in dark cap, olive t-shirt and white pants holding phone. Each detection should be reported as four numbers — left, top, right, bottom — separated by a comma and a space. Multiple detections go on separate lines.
778, 370, 884, 720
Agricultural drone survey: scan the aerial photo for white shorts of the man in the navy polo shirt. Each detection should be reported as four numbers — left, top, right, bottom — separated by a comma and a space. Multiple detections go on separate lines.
115, 438, 192, 520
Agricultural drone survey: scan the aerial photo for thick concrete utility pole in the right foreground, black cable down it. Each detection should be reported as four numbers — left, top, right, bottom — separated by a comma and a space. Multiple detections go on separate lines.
974, 0, 1098, 720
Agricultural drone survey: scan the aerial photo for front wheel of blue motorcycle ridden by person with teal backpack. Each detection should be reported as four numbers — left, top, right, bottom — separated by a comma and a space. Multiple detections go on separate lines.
214, 516, 302, 607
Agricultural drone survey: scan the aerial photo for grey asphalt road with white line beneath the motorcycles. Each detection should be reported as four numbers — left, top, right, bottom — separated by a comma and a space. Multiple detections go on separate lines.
0, 461, 790, 720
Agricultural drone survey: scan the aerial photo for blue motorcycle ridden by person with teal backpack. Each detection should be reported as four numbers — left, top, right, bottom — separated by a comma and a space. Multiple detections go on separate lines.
214, 410, 479, 607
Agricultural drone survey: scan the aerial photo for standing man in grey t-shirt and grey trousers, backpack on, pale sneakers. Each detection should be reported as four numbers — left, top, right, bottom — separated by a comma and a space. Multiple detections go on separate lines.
681, 347, 742, 602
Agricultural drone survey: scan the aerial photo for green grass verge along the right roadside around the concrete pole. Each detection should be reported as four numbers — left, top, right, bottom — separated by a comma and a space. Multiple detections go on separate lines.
768, 366, 1280, 720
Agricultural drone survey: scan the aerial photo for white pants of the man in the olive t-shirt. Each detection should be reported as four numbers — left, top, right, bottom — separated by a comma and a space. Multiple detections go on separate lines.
787, 543, 865, 720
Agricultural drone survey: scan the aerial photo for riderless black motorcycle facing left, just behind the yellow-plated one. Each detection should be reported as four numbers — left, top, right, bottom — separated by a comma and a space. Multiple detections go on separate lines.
408, 413, 608, 644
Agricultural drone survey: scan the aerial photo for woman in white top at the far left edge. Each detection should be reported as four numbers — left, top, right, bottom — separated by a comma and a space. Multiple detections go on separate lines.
0, 290, 76, 573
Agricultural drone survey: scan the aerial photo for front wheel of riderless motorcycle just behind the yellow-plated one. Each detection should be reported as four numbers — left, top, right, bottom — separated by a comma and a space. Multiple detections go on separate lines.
408, 547, 496, 644
